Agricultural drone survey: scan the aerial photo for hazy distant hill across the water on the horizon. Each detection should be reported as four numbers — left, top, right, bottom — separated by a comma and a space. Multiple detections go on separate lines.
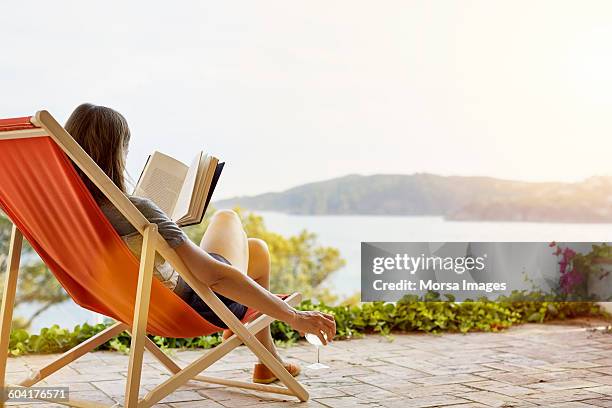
214, 173, 612, 222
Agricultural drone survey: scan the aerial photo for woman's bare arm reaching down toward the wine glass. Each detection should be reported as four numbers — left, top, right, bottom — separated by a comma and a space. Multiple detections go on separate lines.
176, 241, 336, 344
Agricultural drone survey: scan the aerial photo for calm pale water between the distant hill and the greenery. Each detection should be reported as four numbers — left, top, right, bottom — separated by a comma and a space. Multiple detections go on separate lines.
17, 212, 612, 330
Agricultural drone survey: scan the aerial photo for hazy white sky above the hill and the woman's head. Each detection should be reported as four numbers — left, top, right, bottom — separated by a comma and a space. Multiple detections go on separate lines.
0, 0, 612, 198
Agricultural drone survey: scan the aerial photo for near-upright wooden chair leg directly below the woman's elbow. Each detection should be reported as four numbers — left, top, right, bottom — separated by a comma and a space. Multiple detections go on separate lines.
125, 224, 157, 408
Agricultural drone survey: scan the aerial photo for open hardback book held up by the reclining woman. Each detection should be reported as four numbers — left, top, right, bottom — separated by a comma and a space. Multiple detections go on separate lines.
134, 152, 225, 227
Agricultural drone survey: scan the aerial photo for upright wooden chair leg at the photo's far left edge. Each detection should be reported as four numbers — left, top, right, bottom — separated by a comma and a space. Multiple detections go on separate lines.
0, 225, 23, 407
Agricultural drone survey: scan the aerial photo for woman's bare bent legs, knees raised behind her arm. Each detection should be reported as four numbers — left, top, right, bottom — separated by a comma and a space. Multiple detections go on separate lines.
200, 210, 281, 360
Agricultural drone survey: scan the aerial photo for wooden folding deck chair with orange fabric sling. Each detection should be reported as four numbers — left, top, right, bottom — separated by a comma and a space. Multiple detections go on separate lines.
0, 110, 309, 408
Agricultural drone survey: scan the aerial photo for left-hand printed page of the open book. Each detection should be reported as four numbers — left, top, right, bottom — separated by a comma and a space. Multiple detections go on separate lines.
134, 152, 188, 216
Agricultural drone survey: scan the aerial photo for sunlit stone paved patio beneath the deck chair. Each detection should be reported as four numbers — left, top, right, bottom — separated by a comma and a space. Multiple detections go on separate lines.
8, 321, 612, 408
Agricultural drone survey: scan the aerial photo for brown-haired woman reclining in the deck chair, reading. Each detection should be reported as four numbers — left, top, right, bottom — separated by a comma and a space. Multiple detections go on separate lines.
65, 104, 336, 383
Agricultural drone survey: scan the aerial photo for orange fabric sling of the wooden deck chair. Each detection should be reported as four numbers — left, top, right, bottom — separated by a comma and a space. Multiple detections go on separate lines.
0, 117, 257, 337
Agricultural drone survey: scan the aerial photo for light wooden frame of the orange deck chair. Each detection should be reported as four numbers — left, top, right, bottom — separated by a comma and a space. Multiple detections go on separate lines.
0, 110, 309, 408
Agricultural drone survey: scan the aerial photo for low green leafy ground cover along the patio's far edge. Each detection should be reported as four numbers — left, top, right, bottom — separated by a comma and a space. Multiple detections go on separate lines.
9, 294, 604, 356
